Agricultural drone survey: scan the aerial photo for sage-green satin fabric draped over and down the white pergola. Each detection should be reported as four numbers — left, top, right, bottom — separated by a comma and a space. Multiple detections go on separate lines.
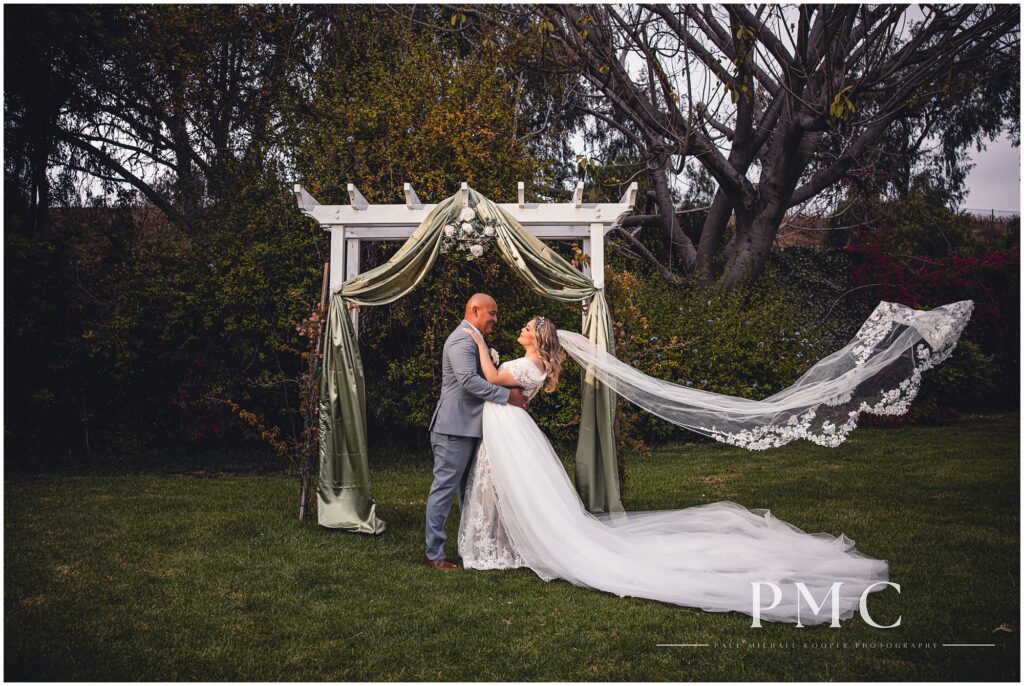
317, 188, 622, 533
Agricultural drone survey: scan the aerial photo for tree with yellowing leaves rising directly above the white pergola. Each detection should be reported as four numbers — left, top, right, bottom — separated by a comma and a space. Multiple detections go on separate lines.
289, 6, 570, 203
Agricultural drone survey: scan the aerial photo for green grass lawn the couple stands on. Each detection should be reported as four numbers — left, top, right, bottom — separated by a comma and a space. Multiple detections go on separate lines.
4, 415, 1020, 681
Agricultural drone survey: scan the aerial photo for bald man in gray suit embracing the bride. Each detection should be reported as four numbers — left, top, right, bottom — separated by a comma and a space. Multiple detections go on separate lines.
423, 293, 527, 571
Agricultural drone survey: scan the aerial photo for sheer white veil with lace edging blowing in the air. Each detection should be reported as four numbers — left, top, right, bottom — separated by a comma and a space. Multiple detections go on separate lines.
558, 300, 974, 449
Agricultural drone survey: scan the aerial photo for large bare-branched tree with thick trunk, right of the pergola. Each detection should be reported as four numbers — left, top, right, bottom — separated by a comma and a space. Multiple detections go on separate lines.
460, 4, 1020, 286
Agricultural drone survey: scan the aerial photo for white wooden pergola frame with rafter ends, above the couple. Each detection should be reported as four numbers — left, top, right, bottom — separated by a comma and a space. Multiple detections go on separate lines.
295, 181, 637, 329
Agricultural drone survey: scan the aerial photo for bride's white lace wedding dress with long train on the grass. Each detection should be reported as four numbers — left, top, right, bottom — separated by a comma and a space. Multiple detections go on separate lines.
459, 357, 889, 625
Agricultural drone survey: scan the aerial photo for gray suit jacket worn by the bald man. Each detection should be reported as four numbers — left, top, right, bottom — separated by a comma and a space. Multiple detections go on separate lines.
430, 319, 509, 438
